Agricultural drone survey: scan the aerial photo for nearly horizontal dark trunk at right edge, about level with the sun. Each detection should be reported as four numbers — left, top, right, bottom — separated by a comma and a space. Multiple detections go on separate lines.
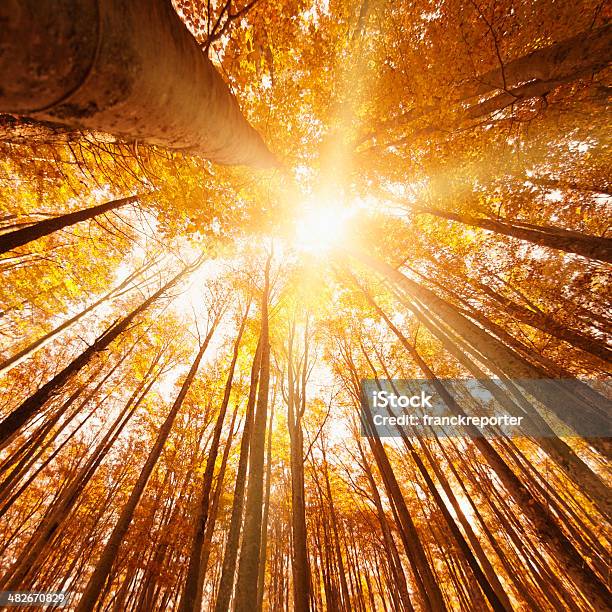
414, 206, 612, 263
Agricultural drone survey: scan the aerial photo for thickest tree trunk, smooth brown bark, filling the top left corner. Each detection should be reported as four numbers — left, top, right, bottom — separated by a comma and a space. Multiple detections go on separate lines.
0, 0, 275, 167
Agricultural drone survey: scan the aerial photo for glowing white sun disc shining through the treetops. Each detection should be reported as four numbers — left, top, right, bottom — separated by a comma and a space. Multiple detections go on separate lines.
294, 201, 352, 254
